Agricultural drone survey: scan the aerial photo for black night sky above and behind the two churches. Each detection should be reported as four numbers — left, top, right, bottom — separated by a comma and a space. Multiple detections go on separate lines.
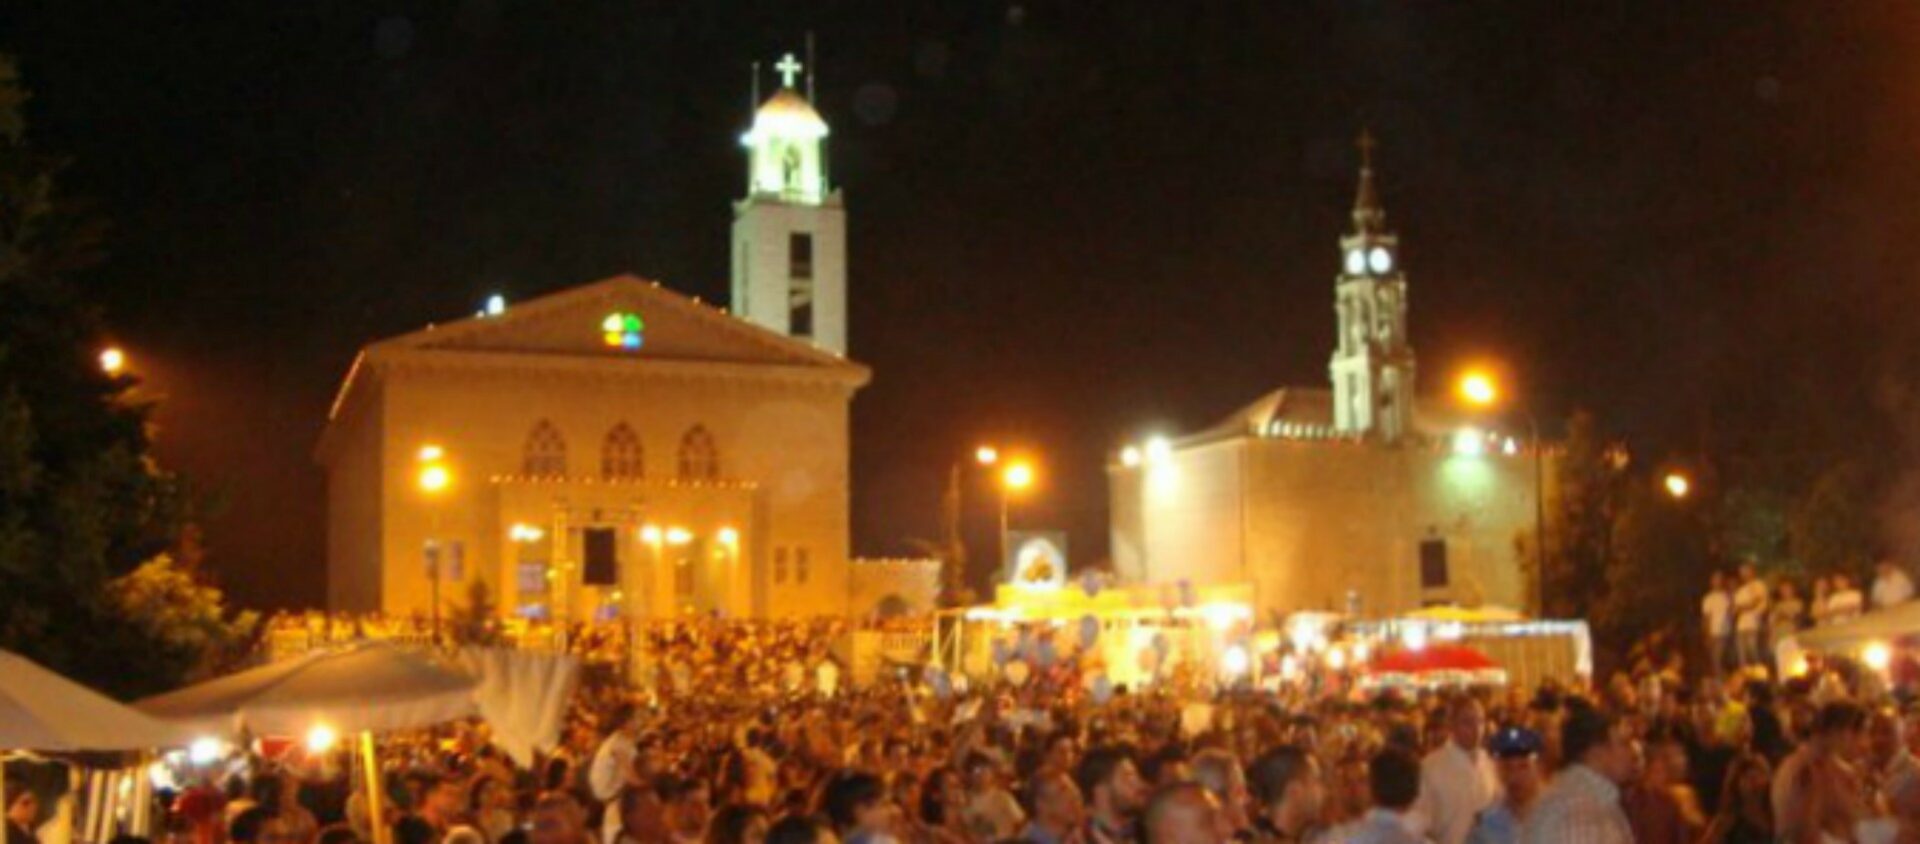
0, 0, 1920, 606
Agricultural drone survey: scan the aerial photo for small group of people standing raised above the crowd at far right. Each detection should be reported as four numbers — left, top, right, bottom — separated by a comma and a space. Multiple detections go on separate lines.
1699, 560, 1914, 675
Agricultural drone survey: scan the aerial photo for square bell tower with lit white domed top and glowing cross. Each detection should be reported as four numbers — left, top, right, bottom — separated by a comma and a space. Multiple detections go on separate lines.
733, 54, 847, 355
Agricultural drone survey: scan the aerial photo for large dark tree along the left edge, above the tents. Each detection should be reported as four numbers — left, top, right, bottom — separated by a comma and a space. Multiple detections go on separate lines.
0, 58, 243, 694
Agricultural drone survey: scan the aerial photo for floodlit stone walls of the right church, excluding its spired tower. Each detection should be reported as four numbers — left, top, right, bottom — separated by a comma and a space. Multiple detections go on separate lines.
1110, 397, 1553, 616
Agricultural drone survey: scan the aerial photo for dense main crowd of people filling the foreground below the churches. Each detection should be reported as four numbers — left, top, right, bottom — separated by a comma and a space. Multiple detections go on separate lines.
22, 621, 1920, 844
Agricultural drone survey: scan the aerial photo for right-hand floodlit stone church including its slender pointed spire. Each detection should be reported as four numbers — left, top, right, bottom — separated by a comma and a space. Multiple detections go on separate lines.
1108, 136, 1551, 616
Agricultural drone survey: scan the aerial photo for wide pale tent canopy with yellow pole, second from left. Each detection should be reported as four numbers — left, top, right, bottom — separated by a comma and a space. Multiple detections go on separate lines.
134, 643, 476, 737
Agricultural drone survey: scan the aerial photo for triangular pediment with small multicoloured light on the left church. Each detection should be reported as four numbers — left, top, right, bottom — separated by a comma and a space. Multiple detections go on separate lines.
376, 276, 854, 366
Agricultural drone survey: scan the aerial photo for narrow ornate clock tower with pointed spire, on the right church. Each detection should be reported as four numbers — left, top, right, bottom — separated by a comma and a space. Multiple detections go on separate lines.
1329, 132, 1413, 443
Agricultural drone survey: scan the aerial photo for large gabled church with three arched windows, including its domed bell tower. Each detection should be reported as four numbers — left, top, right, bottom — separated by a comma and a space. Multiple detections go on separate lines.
317, 56, 870, 620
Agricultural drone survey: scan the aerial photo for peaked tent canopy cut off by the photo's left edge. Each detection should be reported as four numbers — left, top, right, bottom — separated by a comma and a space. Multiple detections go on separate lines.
0, 650, 192, 752
